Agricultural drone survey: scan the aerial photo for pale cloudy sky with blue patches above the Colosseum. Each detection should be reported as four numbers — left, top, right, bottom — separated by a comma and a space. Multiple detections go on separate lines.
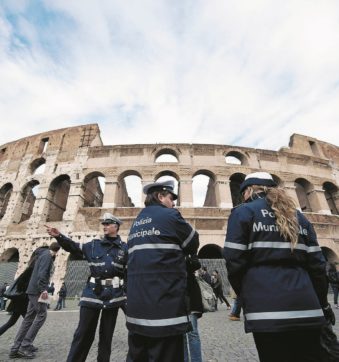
0, 0, 339, 150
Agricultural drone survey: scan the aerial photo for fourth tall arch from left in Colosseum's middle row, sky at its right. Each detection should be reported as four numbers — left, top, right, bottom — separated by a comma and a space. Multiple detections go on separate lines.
82, 171, 105, 207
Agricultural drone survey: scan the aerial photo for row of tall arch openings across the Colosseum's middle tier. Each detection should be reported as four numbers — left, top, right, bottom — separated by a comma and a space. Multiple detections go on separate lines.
0, 166, 338, 223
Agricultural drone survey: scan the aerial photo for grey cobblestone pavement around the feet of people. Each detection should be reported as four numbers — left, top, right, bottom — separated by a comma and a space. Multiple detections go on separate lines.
0, 301, 339, 362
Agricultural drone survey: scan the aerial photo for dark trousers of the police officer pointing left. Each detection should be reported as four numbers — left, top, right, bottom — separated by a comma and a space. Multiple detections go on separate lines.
67, 306, 119, 362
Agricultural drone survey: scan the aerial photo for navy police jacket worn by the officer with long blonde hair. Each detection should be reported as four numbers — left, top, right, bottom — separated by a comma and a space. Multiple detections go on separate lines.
224, 194, 328, 332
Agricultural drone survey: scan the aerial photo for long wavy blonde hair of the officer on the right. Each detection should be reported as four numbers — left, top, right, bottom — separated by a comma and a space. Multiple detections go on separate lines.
249, 185, 299, 251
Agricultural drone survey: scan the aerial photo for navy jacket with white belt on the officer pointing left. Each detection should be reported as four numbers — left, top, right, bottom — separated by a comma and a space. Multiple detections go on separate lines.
56, 234, 128, 309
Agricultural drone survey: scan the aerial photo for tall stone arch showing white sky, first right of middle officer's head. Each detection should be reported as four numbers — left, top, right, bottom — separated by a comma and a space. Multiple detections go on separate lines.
192, 170, 217, 207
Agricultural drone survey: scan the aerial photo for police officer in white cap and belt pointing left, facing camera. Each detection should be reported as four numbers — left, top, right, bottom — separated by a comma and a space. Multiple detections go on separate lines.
46, 213, 128, 362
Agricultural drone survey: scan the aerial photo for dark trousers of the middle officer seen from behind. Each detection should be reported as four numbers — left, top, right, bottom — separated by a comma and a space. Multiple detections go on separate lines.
126, 332, 184, 362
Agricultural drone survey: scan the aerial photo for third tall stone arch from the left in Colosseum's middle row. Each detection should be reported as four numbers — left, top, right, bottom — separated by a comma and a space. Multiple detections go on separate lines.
47, 174, 71, 221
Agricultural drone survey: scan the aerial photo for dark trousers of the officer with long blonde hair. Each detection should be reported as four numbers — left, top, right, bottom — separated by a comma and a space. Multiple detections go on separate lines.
253, 329, 321, 362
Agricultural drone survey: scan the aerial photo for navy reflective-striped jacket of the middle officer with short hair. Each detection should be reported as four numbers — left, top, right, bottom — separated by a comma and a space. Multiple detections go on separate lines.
126, 205, 199, 337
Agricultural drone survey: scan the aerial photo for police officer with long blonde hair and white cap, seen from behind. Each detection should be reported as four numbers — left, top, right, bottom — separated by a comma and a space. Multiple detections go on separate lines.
224, 172, 335, 362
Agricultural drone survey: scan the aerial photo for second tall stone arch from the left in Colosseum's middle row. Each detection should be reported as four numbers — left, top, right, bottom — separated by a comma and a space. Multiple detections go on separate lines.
13, 180, 39, 223
